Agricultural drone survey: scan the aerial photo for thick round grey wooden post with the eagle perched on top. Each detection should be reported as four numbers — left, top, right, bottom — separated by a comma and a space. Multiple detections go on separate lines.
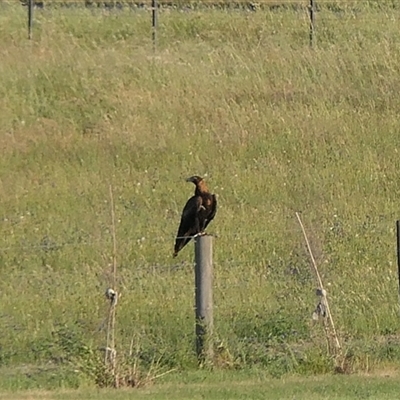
195, 235, 214, 364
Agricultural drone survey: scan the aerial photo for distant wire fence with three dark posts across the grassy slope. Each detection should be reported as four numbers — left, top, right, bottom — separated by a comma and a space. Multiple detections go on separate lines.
5, 0, 400, 43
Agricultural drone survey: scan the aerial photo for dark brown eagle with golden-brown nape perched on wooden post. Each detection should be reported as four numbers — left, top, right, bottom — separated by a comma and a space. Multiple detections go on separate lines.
174, 175, 217, 257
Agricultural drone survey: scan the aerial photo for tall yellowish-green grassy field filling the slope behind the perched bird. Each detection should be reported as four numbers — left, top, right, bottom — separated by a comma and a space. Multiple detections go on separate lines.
0, 3, 400, 389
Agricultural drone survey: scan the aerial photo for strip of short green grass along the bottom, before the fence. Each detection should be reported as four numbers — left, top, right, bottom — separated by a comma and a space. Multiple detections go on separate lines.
0, 371, 398, 400
